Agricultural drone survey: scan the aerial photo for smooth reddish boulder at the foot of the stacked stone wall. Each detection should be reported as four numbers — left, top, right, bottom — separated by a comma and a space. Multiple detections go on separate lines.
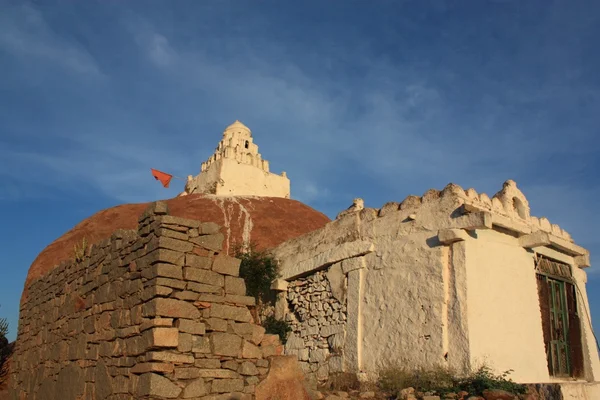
255, 356, 310, 400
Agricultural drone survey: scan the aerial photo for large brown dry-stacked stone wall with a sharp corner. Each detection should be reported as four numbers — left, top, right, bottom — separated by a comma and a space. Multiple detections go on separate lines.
10, 203, 283, 400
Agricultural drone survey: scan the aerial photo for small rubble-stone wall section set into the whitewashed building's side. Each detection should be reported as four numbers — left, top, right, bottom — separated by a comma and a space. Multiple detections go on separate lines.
285, 265, 347, 381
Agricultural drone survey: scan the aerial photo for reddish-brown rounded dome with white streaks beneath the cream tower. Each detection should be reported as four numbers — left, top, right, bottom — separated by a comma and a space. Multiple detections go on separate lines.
25, 195, 330, 296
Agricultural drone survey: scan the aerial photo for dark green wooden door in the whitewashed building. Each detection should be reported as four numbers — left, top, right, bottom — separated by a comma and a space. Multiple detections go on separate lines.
537, 257, 583, 377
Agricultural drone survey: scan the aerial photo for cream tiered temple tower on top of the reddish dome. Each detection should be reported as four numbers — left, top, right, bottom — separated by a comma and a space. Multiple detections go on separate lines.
181, 121, 290, 199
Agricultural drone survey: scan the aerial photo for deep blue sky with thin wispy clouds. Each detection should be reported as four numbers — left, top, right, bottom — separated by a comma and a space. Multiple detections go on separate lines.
0, 0, 600, 339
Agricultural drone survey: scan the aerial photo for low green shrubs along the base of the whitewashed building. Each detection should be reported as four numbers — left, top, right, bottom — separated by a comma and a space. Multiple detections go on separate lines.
378, 365, 527, 396
